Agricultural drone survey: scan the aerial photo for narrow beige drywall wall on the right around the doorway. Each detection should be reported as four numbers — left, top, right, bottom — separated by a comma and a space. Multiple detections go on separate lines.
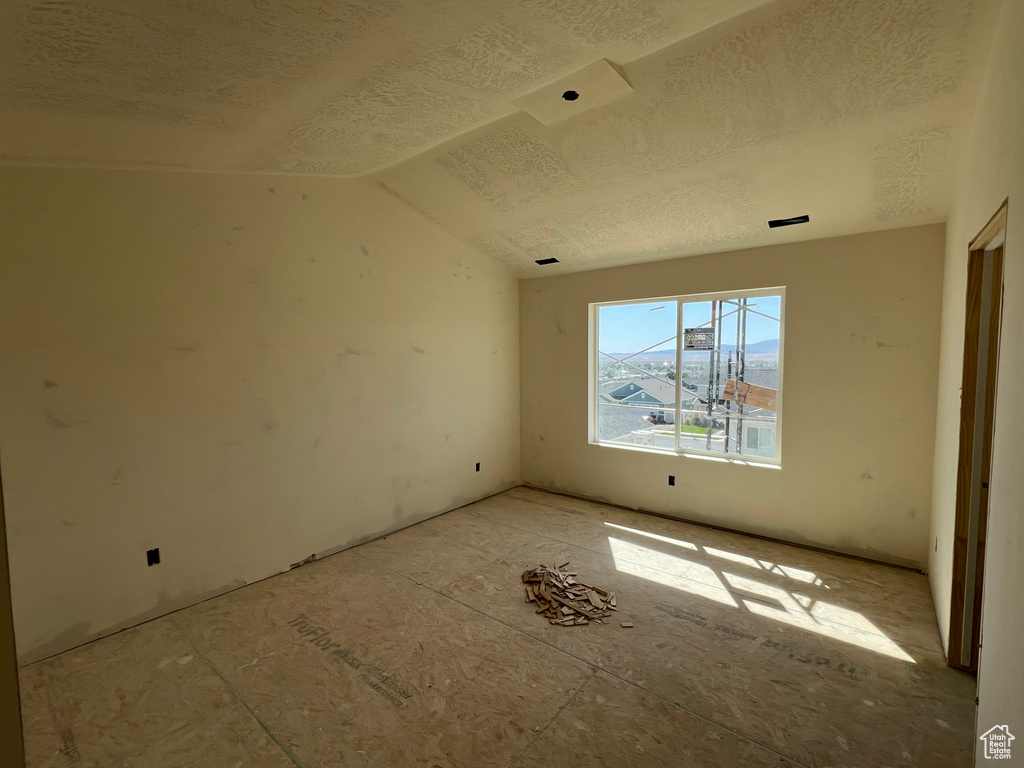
929, 0, 1024, 765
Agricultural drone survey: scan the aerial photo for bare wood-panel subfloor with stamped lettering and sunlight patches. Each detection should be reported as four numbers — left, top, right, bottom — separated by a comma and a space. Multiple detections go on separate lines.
22, 487, 974, 768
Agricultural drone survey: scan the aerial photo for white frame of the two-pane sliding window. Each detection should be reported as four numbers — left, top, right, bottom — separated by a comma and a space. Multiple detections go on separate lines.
587, 286, 785, 468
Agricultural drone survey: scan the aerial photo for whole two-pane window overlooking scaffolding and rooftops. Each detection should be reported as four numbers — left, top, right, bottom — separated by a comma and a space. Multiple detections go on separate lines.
591, 288, 785, 464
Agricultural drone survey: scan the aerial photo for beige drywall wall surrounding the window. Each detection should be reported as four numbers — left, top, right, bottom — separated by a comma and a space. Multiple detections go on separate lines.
520, 224, 944, 567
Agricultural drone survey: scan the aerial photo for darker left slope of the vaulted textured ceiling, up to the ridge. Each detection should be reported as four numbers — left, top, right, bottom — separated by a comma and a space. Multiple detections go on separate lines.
0, 0, 766, 175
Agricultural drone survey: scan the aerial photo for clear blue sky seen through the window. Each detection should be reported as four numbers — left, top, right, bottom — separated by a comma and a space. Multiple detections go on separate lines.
598, 296, 780, 352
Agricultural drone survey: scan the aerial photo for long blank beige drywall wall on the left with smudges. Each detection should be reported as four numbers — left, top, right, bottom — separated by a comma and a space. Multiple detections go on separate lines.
0, 168, 519, 662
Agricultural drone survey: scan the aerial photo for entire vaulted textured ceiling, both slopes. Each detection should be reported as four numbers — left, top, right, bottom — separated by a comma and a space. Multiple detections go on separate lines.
0, 0, 993, 273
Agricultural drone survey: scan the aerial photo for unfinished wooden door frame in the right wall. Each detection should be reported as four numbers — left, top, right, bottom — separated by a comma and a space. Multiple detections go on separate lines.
946, 201, 1008, 672
